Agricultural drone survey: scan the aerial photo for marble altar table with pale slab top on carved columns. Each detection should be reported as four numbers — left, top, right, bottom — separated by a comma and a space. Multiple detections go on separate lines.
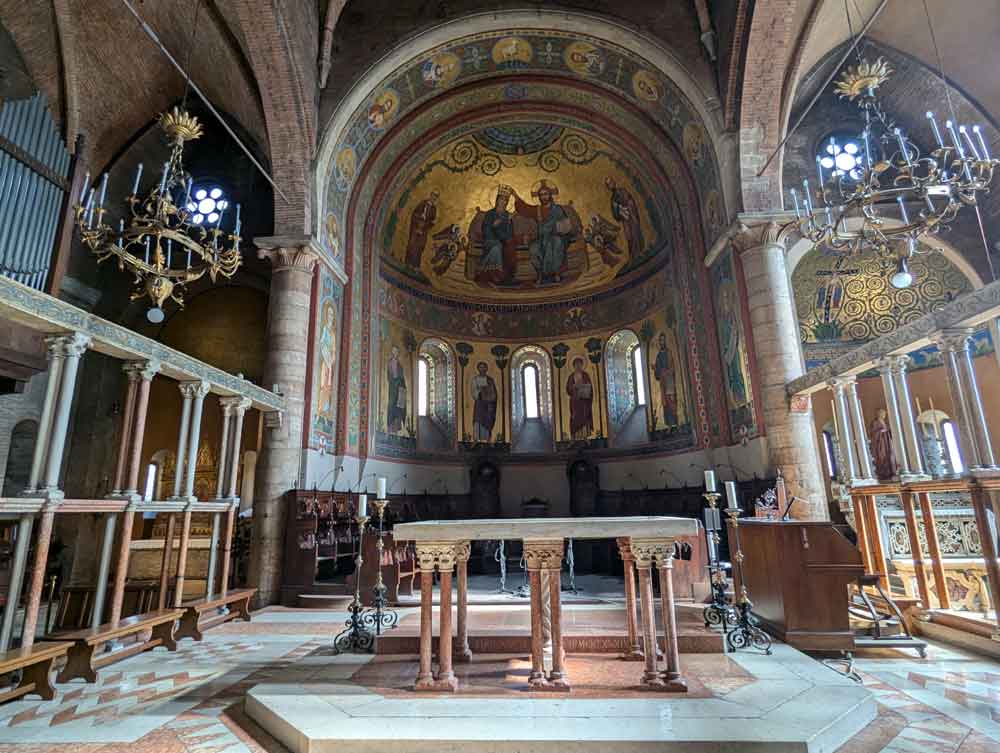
393, 516, 698, 692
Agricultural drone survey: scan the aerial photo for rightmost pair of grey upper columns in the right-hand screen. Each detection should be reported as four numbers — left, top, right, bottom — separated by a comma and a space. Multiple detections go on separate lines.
933, 329, 1000, 476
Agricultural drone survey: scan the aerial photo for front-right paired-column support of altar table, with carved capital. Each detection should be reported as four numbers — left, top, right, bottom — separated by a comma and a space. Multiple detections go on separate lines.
631, 538, 687, 692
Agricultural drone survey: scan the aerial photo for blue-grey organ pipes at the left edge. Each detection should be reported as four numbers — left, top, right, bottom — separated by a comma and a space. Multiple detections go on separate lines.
0, 93, 71, 290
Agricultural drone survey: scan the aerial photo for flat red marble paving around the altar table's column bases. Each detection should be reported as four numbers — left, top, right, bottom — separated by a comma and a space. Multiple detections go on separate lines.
351, 654, 753, 699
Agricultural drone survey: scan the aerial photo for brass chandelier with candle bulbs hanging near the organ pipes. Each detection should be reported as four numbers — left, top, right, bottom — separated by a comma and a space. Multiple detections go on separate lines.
75, 107, 242, 323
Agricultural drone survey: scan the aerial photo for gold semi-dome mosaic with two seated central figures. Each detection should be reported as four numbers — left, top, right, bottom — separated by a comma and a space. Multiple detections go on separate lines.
378, 122, 669, 301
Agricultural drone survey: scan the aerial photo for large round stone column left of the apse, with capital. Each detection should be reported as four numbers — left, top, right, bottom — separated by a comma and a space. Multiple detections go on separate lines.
250, 238, 317, 604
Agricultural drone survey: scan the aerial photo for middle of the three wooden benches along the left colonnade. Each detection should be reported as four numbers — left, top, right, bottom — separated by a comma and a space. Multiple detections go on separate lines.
53, 609, 184, 682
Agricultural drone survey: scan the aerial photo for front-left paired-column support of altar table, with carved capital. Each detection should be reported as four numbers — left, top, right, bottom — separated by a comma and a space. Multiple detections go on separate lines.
413, 541, 461, 692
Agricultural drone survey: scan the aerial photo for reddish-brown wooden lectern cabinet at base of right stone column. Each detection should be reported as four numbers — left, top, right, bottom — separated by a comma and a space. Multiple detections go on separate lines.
736, 518, 865, 651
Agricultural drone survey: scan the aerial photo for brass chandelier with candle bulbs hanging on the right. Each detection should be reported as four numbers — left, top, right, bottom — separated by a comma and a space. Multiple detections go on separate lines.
791, 58, 1000, 288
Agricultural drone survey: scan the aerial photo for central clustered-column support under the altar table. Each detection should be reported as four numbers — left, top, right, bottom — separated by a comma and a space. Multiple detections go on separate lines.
524, 539, 570, 691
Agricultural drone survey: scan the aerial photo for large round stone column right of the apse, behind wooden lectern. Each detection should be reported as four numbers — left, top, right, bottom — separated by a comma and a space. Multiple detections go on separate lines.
736, 221, 828, 516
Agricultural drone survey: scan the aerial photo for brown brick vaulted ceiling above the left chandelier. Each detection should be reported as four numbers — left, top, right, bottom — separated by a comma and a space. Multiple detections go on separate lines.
0, 0, 267, 169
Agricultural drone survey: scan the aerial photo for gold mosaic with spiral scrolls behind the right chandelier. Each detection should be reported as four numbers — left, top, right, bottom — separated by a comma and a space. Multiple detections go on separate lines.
792, 249, 972, 369
